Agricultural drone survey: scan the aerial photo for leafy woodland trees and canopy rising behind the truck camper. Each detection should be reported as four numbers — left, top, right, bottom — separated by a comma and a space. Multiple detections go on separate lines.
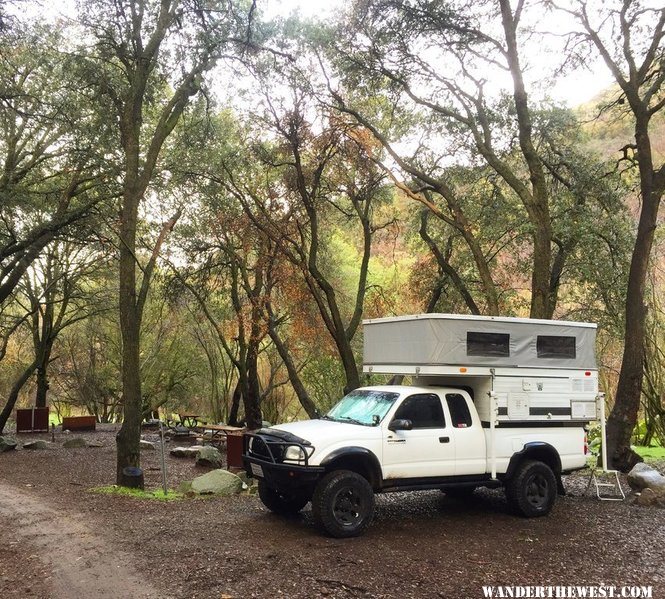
0, 0, 665, 483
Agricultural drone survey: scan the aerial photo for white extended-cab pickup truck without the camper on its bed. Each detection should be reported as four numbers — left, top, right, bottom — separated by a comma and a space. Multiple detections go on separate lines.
244, 386, 586, 537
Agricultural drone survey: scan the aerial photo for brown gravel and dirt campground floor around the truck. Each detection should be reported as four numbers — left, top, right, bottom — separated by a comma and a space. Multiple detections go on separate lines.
0, 427, 665, 599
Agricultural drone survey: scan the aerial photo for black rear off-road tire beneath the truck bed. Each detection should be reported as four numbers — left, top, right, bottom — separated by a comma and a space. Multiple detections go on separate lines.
506, 460, 557, 518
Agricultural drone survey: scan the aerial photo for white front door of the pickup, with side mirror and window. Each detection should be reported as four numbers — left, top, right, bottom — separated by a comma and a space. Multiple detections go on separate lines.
383, 393, 455, 478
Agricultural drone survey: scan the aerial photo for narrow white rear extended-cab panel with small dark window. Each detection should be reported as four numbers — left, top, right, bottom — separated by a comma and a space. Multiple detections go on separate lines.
446, 391, 487, 476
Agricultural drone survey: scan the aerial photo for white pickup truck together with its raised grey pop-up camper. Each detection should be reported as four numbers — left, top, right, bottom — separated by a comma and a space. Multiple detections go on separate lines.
243, 314, 604, 537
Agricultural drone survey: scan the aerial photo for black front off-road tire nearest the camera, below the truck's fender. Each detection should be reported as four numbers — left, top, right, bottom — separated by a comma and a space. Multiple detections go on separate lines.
312, 470, 374, 539
